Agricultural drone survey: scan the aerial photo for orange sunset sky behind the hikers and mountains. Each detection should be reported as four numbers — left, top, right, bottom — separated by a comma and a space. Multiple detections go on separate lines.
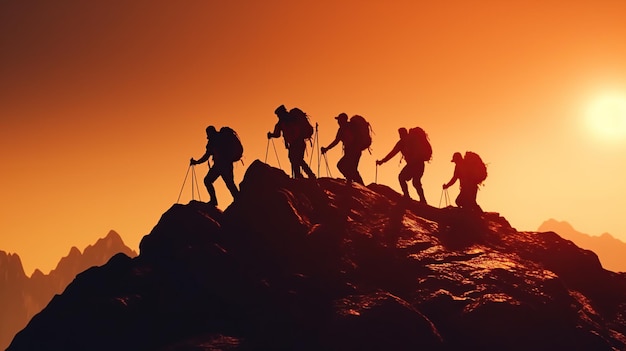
0, 0, 626, 274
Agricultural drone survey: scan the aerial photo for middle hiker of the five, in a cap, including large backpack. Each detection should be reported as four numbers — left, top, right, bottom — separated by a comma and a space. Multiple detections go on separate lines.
320, 113, 372, 185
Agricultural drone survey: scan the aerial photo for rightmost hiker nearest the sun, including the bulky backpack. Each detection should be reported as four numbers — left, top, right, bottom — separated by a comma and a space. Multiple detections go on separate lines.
443, 151, 487, 212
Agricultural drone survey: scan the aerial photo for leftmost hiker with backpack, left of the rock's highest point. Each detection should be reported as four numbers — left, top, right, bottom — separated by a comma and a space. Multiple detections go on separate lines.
190, 126, 243, 206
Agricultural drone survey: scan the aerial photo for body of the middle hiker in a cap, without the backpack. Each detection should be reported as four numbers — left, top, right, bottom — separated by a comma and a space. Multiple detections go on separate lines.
320, 112, 371, 185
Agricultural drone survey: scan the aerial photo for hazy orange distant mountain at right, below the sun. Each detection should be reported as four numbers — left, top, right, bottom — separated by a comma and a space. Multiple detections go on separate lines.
537, 218, 626, 272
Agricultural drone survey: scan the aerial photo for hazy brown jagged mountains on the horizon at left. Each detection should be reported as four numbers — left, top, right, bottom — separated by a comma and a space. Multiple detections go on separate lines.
0, 230, 137, 350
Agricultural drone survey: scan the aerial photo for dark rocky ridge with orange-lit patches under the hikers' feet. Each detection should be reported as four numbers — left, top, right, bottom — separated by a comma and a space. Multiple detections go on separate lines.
8, 161, 626, 351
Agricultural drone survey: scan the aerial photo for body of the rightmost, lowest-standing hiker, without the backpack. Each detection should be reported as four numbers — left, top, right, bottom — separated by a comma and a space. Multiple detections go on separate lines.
443, 152, 486, 212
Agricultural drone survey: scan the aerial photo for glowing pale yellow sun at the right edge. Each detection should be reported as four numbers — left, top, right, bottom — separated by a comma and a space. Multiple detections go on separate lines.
586, 94, 626, 140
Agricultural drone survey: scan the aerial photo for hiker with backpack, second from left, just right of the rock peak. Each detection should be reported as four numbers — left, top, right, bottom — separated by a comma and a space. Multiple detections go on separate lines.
267, 105, 315, 179
